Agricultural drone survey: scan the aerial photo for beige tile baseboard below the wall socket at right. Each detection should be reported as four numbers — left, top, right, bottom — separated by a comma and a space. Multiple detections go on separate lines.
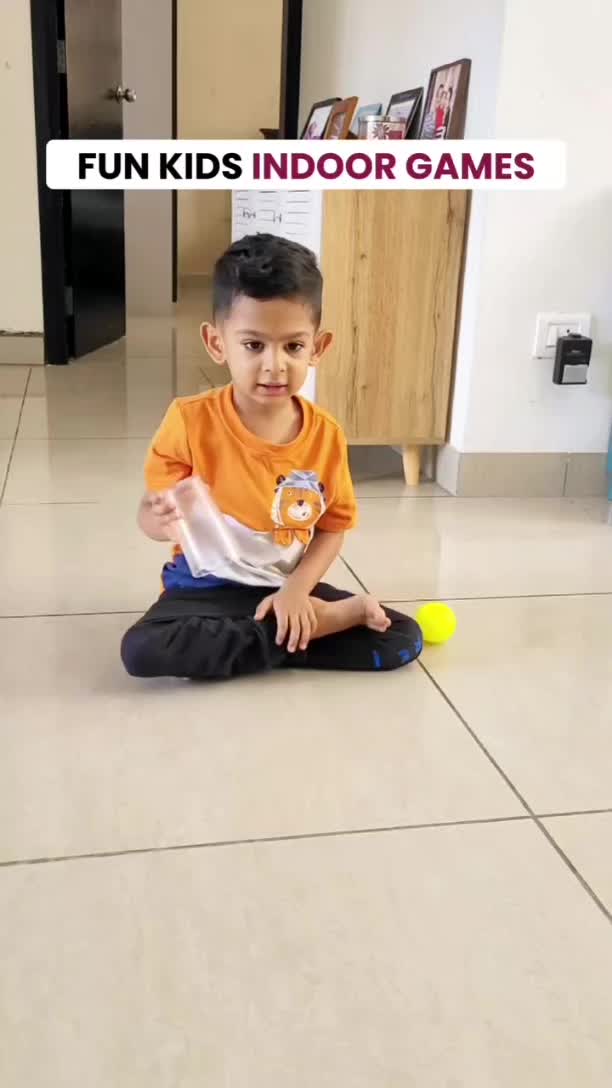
436, 446, 608, 498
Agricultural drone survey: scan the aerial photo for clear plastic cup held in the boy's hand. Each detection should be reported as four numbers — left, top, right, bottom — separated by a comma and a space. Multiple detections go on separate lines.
172, 477, 240, 578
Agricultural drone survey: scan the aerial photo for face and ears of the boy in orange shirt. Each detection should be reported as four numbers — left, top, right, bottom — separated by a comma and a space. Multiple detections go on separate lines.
201, 295, 331, 406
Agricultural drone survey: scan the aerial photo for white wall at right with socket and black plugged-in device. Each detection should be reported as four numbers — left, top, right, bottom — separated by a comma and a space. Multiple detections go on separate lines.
452, 0, 612, 453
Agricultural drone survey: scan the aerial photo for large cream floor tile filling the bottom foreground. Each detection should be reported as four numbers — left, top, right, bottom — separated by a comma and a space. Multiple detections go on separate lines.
0, 824, 612, 1088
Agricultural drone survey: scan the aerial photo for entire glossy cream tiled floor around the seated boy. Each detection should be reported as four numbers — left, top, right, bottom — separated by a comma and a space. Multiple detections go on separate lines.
0, 291, 612, 1088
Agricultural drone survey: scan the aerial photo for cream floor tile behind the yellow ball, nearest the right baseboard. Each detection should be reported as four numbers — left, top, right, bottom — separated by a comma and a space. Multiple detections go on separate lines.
345, 498, 612, 601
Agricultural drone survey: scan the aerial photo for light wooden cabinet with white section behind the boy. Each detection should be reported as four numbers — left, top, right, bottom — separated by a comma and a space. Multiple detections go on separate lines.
232, 190, 468, 482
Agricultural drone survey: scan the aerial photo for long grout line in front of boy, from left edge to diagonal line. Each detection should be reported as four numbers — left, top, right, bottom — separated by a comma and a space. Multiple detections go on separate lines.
0, 815, 529, 870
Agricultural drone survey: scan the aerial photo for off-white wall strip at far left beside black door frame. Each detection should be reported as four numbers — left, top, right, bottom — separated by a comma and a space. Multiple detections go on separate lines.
0, 0, 42, 333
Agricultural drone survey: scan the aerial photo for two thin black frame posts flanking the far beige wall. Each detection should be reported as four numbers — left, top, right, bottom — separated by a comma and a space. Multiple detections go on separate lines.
172, 0, 304, 302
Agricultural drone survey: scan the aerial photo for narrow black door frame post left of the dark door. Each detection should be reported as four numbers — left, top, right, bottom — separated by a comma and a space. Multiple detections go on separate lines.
30, 0, 72, 366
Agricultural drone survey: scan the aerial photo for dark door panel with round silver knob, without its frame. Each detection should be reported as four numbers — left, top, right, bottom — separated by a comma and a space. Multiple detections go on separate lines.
64, 0, 125, 356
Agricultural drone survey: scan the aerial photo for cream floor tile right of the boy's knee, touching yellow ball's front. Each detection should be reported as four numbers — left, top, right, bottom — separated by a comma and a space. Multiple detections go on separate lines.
415, 596, 612, 814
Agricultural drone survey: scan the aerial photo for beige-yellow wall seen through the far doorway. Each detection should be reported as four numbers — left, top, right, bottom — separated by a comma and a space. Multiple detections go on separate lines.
179, 0, 282, 275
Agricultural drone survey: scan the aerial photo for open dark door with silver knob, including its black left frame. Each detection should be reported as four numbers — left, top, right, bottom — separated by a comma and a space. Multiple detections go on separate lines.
30, 0, 125, 364
